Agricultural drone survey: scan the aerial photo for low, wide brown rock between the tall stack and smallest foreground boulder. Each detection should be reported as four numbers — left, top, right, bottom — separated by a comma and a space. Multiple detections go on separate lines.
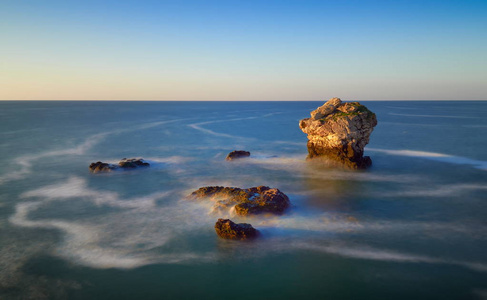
190, 186, 290, 216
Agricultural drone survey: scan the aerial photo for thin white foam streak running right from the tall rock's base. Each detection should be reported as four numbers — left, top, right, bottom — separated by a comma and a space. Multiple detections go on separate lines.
367, 148, 487, 171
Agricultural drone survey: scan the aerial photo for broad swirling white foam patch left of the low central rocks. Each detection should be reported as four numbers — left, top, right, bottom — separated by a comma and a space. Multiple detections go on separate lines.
9, 177, 215, 269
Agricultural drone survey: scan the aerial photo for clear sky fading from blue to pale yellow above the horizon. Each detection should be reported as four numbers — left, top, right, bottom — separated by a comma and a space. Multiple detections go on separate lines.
0, 0, 487, 100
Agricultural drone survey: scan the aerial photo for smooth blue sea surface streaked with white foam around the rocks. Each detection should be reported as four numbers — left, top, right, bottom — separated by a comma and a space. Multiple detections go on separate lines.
0, 101, 487, 299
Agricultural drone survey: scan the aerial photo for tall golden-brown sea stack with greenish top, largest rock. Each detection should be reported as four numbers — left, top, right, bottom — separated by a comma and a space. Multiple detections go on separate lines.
299, 98, 377, 169
